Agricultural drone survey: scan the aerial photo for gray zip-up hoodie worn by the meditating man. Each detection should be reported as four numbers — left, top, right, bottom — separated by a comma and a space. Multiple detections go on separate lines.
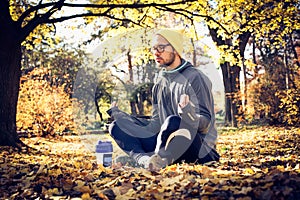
152, 60, 217, 145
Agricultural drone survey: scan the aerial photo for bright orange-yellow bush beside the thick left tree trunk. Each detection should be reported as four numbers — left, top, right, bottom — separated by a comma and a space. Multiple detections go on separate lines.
17, 68, 76, 136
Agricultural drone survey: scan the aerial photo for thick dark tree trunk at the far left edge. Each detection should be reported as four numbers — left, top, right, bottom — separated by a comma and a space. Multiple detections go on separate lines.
0, 26, 22, 147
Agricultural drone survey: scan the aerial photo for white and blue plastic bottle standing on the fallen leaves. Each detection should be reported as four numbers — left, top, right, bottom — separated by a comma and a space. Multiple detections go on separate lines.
96, 140, 113, 167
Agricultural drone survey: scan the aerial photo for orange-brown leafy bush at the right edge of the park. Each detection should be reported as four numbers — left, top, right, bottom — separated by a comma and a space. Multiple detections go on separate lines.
246, 59, 300, 126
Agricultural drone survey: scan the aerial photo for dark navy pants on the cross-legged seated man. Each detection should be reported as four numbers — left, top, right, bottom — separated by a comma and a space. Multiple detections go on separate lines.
109, 115, 219, 163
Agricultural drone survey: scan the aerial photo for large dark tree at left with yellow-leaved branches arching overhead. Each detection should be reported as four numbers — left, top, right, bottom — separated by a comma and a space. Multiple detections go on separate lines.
0, 0, 299, 147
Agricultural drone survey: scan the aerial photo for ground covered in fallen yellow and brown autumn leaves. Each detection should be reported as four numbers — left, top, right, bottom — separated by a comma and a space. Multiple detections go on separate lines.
0, 127, 300, 200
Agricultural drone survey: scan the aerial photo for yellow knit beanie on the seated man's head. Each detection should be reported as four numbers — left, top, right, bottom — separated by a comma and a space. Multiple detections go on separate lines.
156, 29, 183, 56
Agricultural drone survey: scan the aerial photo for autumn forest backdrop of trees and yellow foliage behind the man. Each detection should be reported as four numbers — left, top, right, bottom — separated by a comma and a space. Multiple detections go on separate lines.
0, 0, 300, 199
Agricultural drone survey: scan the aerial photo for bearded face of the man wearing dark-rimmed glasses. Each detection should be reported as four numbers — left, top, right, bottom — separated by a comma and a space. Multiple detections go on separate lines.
151, 35, 175, 67
